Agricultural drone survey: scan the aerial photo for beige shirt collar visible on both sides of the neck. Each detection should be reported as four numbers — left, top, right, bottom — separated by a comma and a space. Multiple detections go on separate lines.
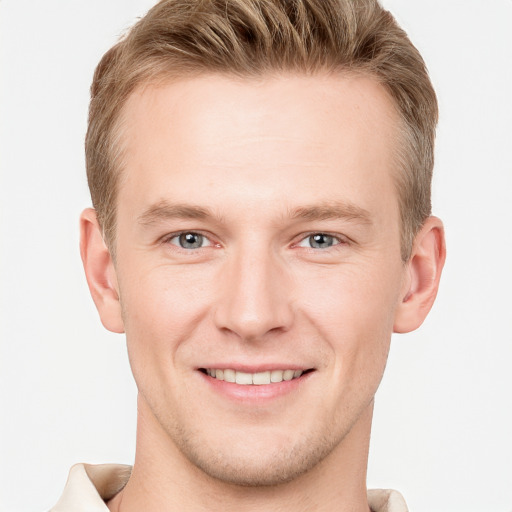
49, 464, 408, 512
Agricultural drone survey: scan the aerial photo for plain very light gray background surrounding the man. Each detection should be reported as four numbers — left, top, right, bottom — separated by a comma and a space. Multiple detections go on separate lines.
0, 0, 512, 512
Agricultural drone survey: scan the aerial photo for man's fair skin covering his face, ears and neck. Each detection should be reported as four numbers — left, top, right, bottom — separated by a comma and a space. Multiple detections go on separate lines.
81, 75, 445, 512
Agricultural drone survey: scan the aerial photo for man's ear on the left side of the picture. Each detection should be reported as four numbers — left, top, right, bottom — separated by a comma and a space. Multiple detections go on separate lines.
80, 208, 124, 333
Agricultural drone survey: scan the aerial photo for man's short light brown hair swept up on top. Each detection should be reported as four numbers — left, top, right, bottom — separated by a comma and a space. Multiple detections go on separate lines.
85, 0, 438, 261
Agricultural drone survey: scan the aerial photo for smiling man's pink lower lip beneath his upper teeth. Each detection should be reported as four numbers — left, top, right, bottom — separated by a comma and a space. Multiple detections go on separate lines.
198, 372, 314, 403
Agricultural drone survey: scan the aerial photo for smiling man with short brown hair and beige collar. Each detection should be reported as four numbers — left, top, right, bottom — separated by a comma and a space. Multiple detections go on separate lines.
53, 0, 445, 512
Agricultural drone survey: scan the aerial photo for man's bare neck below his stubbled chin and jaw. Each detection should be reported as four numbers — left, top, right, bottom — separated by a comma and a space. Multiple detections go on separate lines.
108, 397, 373, 512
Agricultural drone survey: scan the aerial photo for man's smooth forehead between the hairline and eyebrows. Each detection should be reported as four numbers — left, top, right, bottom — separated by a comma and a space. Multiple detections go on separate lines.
118, 74, 399, 223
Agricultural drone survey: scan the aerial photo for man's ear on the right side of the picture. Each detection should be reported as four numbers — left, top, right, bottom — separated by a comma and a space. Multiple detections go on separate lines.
393, 217, 446, 333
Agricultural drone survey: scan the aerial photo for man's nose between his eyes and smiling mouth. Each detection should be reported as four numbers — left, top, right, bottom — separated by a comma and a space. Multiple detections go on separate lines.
215, 247, 293, 341
